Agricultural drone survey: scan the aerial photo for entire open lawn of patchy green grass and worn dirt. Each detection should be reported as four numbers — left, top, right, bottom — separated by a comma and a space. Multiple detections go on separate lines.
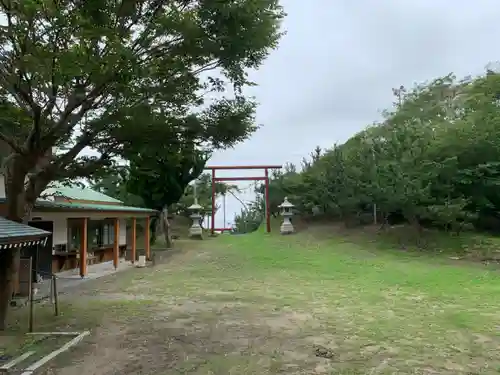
7, 226, 500, 375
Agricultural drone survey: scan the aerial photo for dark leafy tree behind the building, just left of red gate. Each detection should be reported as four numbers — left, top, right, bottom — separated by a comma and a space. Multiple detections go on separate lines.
122, 97, 256, 216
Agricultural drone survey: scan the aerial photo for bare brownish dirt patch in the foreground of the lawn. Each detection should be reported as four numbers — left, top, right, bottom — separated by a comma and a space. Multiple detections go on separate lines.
46, 303, 328, 375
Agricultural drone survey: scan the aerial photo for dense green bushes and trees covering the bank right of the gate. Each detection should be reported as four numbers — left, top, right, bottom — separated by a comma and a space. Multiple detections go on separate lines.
261, 68, 500, 235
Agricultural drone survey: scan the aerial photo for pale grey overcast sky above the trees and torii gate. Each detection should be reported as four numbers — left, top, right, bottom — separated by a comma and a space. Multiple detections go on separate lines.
209, 0, 500, 226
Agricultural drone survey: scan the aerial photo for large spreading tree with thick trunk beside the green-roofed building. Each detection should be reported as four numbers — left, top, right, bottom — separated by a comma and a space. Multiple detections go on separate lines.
0, 0, 283, 328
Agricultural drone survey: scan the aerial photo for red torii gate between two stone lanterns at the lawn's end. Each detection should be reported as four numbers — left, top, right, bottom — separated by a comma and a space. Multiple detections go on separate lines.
205, 165, 282, 235
